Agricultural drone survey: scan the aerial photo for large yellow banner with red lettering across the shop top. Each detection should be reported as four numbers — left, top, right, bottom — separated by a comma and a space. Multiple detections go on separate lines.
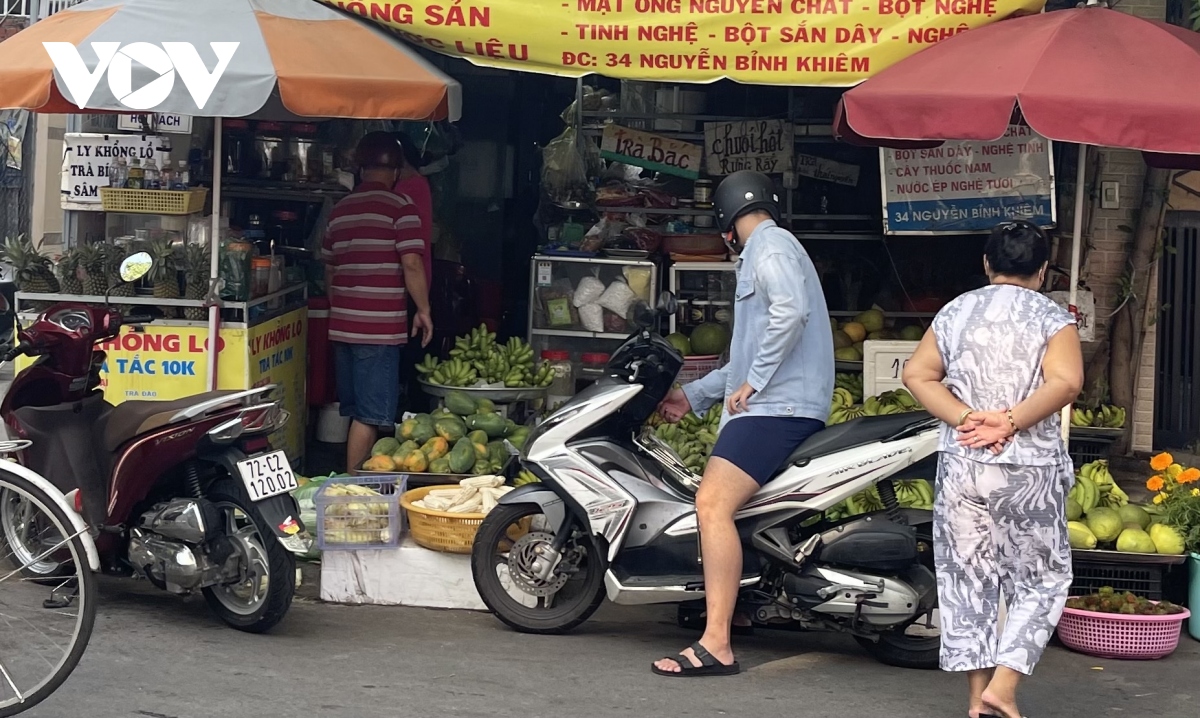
322, 0, 1045, 86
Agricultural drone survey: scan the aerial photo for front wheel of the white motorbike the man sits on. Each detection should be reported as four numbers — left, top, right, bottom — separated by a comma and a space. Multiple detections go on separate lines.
470, 504, 605, 634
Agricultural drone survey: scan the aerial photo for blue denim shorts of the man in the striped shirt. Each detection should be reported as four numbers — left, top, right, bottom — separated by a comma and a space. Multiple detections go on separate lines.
334, 342, 404, 429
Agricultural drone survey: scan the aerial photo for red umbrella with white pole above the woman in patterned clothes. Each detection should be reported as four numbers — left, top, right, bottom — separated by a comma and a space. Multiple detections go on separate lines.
834, 0, 1200, 433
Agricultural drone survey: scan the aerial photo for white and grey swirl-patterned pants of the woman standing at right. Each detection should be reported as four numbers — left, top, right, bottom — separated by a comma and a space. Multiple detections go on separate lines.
934, 454, 1075, 675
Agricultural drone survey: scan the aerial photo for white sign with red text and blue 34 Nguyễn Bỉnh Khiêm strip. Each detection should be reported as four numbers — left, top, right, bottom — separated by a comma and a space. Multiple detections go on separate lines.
880, 125, 1055, 234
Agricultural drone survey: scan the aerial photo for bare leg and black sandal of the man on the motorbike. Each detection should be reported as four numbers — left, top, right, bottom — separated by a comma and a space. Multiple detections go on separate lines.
654, 456, 758, 672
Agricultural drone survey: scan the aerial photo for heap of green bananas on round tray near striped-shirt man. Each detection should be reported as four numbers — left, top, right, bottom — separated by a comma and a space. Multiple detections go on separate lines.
416, 325, 554, 389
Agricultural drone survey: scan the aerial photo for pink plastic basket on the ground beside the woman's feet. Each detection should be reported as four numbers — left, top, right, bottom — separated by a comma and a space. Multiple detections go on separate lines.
1058, 609, 1192, 660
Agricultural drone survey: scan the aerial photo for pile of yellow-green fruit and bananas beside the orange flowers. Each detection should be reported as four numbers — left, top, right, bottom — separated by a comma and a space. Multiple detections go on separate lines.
1067, 460, 1183, 556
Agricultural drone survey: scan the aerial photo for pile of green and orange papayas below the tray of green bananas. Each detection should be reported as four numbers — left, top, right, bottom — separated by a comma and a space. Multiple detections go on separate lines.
362, 391, 529, 475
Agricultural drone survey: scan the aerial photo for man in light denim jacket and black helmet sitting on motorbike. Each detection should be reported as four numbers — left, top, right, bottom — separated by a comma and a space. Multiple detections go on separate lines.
654, 172, 834, 676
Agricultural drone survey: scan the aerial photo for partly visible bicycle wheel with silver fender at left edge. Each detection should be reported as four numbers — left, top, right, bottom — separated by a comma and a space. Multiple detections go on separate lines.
0, 472, 96, 718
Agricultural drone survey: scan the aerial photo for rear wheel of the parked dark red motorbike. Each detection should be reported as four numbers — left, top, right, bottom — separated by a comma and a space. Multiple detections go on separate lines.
204, 479, 296, 633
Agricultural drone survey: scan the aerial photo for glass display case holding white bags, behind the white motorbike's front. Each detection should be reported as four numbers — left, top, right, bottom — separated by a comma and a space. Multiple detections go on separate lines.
529, 255, 659, 387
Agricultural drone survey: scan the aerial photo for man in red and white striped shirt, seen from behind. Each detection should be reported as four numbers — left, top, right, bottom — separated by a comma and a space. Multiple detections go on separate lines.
322, 132, 433, 471
